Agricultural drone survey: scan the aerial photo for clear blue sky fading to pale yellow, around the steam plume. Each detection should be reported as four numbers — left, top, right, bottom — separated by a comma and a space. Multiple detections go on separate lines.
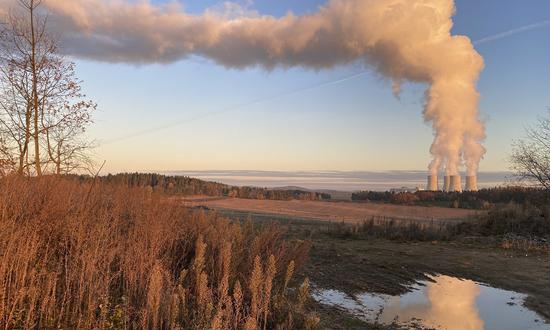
70, 0, 550, 172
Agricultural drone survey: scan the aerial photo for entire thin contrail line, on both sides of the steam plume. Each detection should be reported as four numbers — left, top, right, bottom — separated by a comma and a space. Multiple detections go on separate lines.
101, 20, 550, 145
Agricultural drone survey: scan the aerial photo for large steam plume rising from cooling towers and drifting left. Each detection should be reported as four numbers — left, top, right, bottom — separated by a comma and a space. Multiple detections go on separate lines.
0, 0, 485, 175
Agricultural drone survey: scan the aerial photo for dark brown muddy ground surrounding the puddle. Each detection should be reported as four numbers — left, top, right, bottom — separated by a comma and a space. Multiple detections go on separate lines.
219, 212, 550, 329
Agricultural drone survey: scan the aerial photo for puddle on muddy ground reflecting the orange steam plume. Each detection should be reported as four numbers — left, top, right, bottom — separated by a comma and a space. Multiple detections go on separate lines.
312, 275, 550, 330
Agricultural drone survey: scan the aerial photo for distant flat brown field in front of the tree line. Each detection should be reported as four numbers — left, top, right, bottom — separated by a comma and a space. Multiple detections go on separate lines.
183, 196, 480, 223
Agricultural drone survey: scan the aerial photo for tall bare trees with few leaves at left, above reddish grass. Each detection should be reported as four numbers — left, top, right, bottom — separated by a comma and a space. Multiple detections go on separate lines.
0, 0, 96, 175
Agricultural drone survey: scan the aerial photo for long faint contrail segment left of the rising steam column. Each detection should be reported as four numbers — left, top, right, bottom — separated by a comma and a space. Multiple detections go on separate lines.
101, 70, 368, 145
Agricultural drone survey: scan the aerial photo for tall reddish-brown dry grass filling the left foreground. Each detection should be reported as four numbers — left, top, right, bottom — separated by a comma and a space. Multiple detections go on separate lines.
0, 178, 316, 329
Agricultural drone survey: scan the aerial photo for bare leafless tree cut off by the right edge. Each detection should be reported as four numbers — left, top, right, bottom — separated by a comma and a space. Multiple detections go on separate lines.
510, 109, 550, 190
